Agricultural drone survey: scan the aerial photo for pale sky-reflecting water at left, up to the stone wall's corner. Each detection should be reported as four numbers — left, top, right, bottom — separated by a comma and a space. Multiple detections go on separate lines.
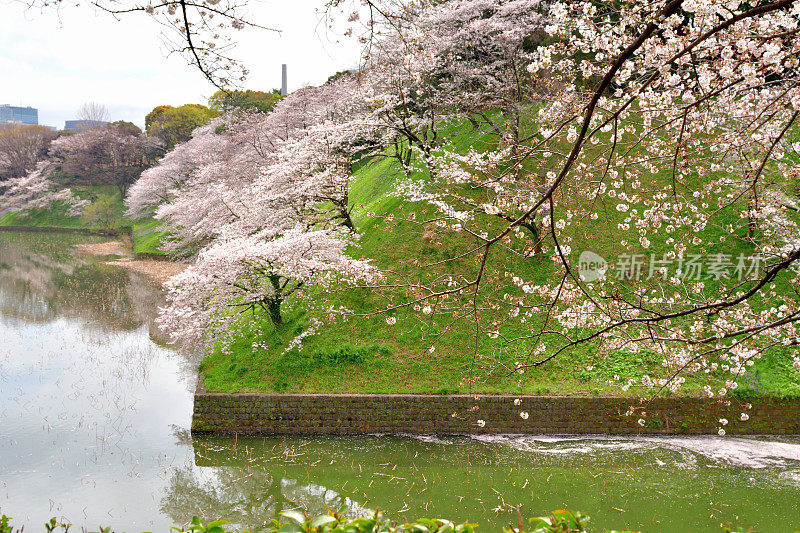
0, 232, 193, 530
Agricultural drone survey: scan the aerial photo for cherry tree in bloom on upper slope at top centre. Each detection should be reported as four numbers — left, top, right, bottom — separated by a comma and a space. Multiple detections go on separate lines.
354, 0, 552, 252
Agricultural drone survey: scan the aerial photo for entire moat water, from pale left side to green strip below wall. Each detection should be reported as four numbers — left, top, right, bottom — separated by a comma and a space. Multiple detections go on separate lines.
0, 232, 800, 532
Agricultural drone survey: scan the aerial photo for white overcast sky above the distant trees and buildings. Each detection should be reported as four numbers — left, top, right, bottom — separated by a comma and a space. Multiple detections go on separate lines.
0, 0, 359, 129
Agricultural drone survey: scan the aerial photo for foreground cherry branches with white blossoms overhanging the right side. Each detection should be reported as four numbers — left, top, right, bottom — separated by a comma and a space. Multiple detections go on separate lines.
364, 1, 800, 412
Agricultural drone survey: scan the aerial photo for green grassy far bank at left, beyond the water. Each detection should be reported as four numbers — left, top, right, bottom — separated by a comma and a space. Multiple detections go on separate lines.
0, 187, 164, 256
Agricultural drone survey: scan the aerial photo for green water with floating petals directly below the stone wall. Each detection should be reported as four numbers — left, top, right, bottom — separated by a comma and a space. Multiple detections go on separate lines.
180, 436, 800, 531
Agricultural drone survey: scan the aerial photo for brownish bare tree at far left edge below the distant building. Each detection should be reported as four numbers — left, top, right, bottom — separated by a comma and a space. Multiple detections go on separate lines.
0, 125, 56, 186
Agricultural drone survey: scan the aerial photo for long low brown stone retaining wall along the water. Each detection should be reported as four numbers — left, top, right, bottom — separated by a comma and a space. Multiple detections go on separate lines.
192, 389, 800, 435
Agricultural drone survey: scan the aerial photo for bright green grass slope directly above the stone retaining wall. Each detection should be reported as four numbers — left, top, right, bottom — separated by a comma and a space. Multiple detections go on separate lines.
201, 117, 800, 397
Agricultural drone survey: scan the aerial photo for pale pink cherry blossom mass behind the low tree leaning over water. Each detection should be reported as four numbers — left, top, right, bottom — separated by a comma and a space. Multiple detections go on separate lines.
128, 78, 382, 249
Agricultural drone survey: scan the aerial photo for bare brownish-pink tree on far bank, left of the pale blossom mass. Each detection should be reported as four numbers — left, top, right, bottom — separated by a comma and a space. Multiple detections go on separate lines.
50, 122, 163, 196
